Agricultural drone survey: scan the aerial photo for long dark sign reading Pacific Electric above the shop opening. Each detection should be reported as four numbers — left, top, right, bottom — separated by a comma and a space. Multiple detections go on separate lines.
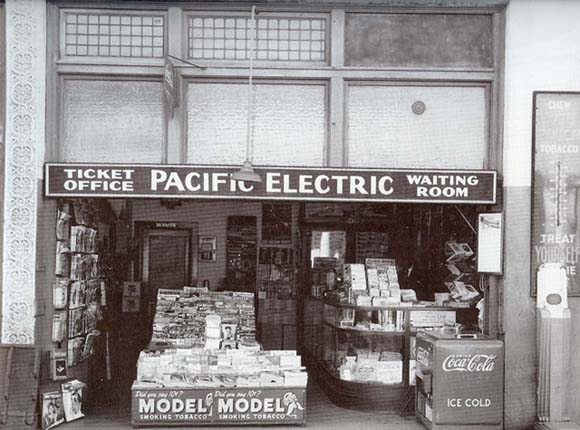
45, 163, 497, 204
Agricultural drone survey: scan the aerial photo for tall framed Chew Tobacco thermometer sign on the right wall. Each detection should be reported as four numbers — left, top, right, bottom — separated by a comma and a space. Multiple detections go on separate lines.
531, 92, 580, 296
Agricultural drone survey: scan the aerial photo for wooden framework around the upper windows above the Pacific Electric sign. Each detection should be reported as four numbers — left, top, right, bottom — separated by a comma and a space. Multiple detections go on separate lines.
46, 0, 505, 174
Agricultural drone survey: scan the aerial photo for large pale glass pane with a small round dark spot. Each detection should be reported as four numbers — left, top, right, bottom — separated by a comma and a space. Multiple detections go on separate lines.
347, 85, 487, 169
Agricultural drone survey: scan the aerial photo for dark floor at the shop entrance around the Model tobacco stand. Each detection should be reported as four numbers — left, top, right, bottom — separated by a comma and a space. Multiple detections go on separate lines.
60, 383, 424, 430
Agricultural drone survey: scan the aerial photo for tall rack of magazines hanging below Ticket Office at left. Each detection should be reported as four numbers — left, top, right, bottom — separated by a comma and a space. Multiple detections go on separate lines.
52, 200, 110, 366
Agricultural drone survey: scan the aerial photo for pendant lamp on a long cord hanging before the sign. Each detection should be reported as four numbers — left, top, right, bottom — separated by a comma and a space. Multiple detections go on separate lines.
232, 6, 262, 182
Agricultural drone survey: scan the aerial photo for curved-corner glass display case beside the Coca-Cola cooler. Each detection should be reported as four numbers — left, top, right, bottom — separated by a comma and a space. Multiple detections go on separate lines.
303, 297, 461, 411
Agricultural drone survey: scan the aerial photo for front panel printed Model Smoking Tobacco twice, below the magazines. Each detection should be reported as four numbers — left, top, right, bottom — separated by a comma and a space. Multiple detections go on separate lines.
131, 385, 306, 427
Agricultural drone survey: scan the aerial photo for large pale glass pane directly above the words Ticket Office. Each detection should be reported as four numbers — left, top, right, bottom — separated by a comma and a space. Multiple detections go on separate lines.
62, 80, 163, 163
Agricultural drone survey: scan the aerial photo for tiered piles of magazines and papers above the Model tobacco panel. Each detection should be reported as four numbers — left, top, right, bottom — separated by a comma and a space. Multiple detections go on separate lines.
139, 287, 307, 388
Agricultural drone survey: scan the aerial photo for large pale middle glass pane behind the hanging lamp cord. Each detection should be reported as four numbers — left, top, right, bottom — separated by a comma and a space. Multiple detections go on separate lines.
187, 83, 326, 166
